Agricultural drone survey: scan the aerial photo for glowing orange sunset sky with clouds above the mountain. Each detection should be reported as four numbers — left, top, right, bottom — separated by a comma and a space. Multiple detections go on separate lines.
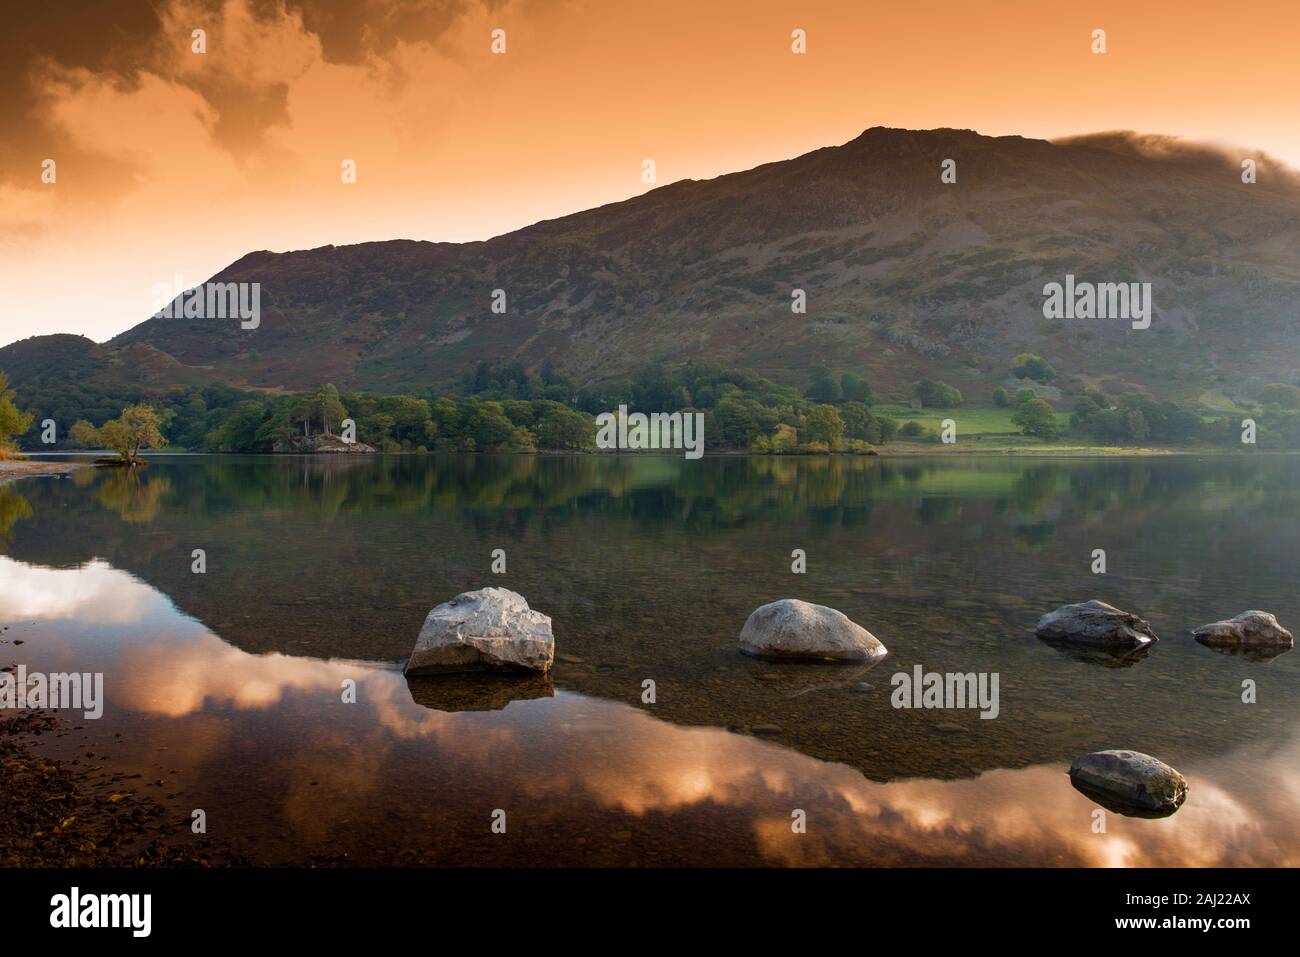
0, 0, 1300, 345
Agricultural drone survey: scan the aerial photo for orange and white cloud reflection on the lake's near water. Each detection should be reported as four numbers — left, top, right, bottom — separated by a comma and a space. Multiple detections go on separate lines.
10, 548, 1300, 866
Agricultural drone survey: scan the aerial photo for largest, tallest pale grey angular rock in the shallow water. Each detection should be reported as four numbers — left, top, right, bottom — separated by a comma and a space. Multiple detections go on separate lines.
406, 588, 555, 675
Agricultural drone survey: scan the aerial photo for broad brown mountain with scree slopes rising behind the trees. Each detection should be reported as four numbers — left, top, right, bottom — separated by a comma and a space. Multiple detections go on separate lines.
0, 129, 1300, 399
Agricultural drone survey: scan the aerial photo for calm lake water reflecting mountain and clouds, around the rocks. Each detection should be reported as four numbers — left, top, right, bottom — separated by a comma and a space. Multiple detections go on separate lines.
0, 456, 1300, 866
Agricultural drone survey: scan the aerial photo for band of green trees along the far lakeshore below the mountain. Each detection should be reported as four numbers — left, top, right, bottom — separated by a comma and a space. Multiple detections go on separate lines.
0, 354, 1300, 459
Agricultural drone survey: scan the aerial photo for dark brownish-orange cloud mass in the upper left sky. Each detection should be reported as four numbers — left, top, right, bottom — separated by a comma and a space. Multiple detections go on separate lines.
0, 0, 533, 198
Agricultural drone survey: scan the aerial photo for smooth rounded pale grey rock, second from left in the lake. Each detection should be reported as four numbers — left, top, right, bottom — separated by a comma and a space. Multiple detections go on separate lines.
740, 598, 888, 662
